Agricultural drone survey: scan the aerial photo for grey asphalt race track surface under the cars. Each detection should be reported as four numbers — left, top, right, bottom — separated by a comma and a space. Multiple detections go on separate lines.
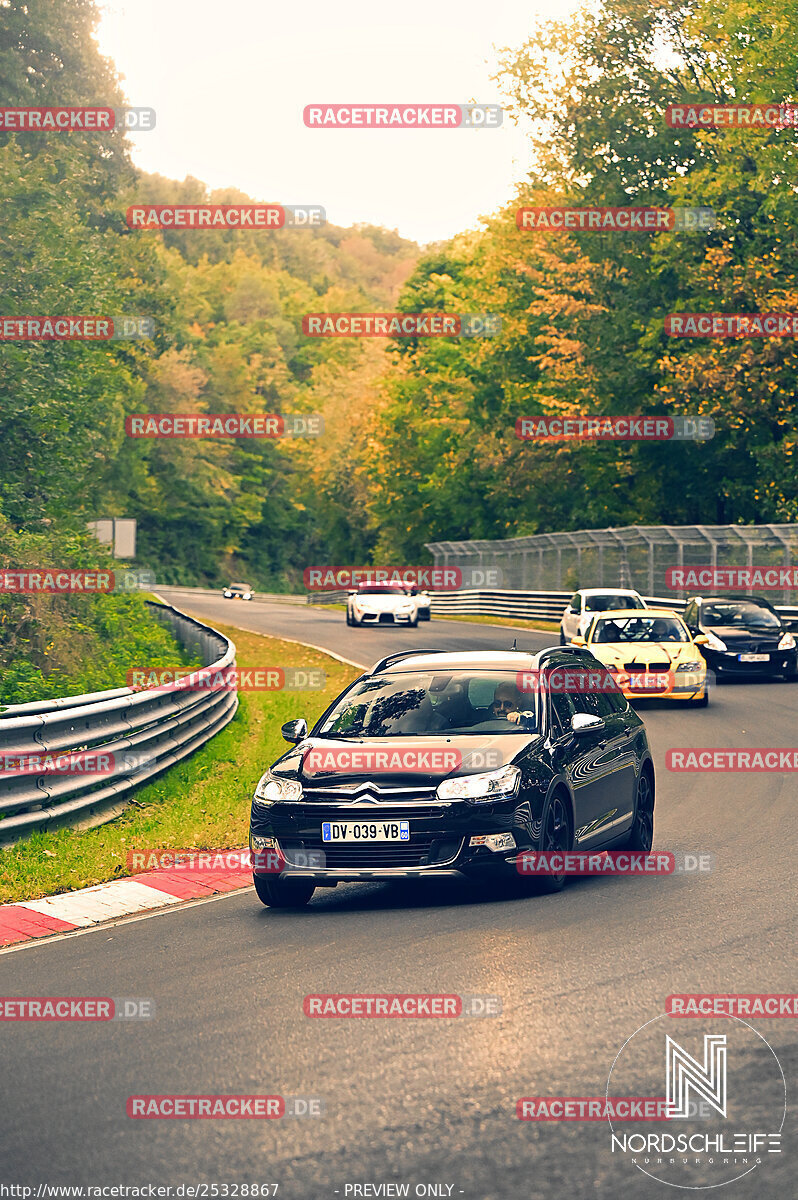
0, 589, 798, 1200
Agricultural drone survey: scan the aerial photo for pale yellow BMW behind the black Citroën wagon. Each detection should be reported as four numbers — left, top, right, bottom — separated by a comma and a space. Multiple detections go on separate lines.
571, 608, 709, 708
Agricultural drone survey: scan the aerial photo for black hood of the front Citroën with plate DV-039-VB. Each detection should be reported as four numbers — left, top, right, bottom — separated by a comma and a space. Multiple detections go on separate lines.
274, 733, 540, 787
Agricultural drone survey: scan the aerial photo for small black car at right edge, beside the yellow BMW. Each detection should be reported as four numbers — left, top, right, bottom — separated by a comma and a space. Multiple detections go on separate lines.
683, 595, 798, 679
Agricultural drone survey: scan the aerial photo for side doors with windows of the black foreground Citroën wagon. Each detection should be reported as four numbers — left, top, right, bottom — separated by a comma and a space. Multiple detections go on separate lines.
572, 691, 636, 850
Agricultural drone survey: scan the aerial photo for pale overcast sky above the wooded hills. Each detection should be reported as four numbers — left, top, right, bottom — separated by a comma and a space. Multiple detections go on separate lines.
98, 0, 575, 242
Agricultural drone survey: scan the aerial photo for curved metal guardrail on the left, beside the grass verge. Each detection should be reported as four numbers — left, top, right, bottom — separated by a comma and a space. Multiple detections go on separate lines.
0, 601, 239, 845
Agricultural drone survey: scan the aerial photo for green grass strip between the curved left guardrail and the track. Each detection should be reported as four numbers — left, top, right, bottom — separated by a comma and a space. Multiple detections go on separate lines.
0, 624, 360, 902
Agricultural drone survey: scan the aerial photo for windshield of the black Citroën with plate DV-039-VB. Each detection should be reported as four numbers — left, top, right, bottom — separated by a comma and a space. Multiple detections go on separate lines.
314, 671, 539, 738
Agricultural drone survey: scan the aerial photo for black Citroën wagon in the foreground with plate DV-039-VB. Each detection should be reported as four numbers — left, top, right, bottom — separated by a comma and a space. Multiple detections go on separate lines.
250, 647, 654, 907
